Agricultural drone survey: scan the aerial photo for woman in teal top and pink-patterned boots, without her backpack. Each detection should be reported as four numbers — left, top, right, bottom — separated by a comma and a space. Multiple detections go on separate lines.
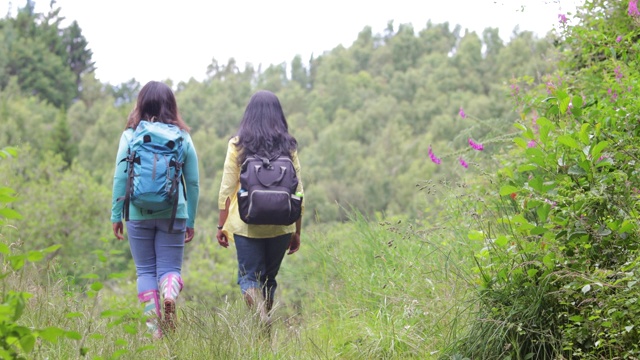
111, 81, 199, 338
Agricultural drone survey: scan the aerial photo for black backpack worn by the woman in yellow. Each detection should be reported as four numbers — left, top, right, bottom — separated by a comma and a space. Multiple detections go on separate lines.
238, 155, 302, 225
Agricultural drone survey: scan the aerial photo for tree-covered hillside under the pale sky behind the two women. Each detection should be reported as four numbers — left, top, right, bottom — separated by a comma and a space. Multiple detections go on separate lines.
0, 0, 554, 250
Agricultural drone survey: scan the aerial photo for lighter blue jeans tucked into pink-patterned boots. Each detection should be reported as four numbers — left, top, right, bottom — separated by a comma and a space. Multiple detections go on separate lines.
127, 219, 187, 293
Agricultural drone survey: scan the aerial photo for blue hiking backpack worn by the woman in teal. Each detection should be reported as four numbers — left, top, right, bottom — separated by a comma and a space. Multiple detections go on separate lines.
121, 120, 187, 232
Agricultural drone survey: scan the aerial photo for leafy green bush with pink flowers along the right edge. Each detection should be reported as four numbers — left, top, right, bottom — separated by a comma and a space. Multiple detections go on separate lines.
451, 1, 640, 359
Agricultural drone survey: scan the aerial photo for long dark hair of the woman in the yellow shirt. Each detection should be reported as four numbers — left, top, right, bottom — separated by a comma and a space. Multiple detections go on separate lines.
236, 90, 298, 164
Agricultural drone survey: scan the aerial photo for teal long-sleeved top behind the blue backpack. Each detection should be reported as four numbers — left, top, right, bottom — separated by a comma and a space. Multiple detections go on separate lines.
111, 129, 200, 228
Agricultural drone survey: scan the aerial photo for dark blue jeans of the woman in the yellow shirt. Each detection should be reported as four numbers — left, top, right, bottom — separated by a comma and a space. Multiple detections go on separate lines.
233, 234, 291, 300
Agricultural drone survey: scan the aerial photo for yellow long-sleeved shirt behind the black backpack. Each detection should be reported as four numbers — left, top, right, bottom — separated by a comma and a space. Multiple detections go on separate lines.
218, 137, 306, 239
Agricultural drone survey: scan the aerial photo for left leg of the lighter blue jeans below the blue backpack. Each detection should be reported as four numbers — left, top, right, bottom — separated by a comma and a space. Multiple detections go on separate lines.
127, 220, 158, 293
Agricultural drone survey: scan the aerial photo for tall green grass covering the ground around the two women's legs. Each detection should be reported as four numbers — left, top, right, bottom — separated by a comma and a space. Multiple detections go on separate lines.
4, 201, 480, 359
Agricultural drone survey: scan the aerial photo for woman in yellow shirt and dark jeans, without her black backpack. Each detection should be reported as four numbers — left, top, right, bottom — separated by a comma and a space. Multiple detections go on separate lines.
216, 90, 304, 323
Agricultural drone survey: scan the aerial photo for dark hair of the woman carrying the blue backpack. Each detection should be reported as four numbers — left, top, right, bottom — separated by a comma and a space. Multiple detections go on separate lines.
125, 81, 189, 131
